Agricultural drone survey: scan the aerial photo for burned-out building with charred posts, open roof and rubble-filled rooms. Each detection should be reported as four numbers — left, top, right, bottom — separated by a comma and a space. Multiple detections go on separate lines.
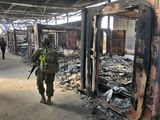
0, 0, 160, 120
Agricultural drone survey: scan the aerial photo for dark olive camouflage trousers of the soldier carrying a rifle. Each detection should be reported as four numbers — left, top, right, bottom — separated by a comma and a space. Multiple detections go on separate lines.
36, 68, 55, 97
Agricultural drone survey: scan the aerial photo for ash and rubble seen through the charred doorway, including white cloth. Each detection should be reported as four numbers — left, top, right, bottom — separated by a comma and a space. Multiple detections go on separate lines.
93, 56, 133, 120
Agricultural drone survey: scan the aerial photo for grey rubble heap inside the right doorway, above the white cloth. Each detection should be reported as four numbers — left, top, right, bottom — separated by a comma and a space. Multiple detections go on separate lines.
100, 56, 133, 84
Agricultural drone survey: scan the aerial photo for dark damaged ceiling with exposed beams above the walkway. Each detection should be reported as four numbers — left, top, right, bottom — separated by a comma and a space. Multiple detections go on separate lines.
0, 0, 105, 19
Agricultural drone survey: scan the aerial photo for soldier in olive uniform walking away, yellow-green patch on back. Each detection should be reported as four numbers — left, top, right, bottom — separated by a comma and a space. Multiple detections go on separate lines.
31, 39, 59, 105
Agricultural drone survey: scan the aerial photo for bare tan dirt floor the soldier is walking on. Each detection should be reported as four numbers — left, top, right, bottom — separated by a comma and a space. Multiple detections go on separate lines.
0, 52, 90, 120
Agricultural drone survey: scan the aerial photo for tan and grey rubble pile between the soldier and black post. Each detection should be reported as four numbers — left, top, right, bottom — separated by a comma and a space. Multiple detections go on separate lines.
57, 56, 80, 90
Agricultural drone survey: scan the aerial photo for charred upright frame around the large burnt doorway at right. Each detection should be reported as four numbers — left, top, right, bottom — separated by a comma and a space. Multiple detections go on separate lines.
81, 0, 159, 119
